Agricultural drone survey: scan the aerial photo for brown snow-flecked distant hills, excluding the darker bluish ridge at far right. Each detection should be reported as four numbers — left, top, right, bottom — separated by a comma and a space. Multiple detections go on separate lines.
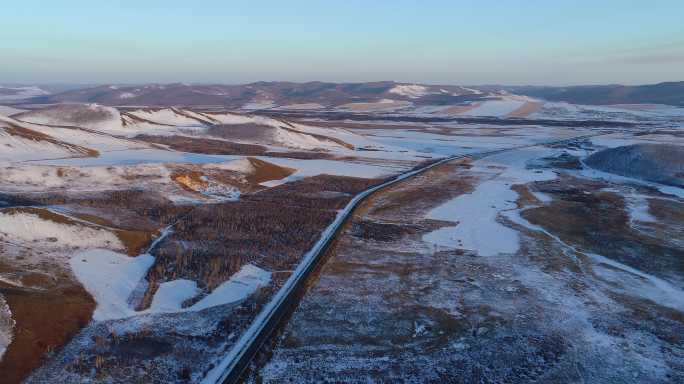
22, 82, 487, 109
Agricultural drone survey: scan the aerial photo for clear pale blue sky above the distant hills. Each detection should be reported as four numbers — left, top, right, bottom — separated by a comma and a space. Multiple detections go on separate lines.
0, 0, 684, 84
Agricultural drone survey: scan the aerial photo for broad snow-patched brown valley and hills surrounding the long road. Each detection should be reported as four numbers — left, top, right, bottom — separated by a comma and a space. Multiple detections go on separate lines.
0, 82, 684, 383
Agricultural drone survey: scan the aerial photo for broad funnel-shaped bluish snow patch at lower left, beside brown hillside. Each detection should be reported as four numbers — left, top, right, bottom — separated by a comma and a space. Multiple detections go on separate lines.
69, 249, 154, 321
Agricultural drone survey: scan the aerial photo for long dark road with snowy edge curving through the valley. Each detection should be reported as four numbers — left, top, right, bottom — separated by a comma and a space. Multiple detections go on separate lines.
202, 131, 613, 384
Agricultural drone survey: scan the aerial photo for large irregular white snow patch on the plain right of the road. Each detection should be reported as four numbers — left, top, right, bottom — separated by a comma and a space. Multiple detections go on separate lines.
423, 149, 556, 256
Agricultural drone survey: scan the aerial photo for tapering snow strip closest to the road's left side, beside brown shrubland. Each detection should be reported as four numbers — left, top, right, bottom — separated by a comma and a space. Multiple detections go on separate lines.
188, 264, 271, 311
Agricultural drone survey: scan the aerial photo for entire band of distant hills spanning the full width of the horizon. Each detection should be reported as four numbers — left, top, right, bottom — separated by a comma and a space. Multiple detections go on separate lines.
0, 81, 684, 109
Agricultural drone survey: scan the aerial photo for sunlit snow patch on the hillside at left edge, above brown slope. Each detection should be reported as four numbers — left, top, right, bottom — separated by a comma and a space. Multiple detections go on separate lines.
0, 212, 125, 249
